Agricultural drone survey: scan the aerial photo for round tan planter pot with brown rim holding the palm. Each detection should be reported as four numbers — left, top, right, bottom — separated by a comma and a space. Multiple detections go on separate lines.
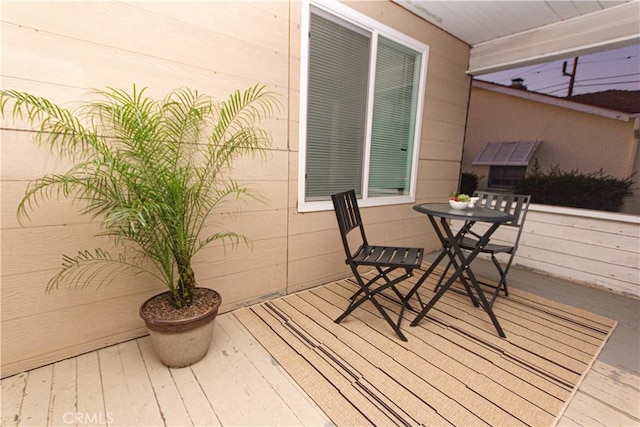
139, 288, 222, 368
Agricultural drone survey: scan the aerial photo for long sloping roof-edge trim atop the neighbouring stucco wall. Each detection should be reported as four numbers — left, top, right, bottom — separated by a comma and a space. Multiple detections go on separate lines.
472, 79, 637, 122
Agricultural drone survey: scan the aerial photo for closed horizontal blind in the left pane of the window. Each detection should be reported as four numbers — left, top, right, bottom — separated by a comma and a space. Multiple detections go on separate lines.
305, 13, 371, 201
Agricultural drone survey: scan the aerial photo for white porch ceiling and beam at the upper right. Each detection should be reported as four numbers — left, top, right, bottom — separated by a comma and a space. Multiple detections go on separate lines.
392, 0, 640, 75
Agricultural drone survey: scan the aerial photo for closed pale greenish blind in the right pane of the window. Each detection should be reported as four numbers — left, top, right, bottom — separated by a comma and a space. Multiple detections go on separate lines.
368, 36, 420, 197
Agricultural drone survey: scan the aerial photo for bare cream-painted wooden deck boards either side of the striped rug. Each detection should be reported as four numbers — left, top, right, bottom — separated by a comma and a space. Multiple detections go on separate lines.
0, 262, 640, 426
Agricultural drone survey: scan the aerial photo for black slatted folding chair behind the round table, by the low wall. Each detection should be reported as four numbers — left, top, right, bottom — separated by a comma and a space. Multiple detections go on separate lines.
434, 191, 531, 305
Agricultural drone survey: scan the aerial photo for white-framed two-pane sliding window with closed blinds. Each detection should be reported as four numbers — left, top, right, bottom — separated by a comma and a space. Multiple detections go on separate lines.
299, 1, 428, 210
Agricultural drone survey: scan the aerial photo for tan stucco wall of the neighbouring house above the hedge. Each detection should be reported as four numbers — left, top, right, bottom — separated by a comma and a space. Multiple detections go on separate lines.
462, 87, 640, 213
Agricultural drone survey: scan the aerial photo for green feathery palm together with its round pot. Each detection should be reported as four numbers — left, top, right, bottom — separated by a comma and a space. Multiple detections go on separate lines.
0, 85, 278, 367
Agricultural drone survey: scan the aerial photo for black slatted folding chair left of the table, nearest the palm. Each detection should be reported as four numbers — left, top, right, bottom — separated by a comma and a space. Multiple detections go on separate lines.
331, 190, 424, 341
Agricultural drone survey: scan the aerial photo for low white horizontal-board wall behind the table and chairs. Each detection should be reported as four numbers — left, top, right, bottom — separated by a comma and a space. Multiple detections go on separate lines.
452, 204, 640, 298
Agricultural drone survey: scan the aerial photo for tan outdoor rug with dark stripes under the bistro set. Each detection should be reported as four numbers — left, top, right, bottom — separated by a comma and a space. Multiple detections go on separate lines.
235, 266, 616, 426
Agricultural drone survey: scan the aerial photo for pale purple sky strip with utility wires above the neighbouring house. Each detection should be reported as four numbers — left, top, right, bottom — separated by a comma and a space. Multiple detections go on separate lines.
476, 44, 640, 97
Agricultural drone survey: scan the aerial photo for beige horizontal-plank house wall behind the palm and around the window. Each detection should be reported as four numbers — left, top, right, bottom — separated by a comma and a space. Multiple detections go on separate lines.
0, 0, 470, 377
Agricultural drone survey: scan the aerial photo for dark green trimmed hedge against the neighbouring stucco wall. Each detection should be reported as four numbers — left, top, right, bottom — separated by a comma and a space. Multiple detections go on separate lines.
514, 164, 633, 212
